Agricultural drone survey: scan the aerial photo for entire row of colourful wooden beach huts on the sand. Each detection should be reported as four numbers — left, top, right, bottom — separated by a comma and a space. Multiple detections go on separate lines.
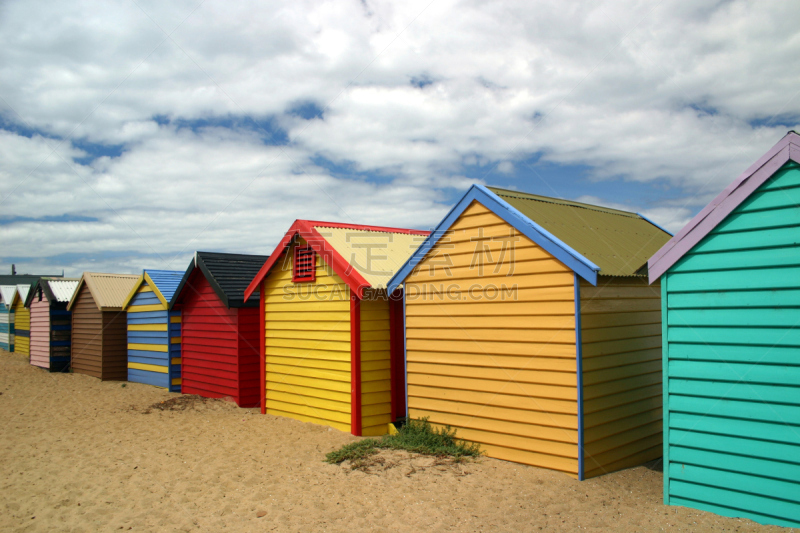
0, 132, 800, 527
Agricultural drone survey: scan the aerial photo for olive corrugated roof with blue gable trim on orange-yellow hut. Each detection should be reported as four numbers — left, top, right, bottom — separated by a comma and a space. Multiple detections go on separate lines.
389, 185, 669, 291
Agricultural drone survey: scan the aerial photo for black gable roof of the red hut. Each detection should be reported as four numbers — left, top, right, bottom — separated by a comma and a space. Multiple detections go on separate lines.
169, 252, 269, 309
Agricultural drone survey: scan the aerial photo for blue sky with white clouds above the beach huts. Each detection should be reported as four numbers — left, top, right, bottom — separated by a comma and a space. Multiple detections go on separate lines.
0, 0, 800, 276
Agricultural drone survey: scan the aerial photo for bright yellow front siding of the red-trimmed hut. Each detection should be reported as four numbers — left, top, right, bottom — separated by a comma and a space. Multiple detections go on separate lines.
261, 239, 352, 432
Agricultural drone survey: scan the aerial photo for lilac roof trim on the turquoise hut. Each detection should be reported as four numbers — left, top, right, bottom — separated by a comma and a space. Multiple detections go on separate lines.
648, 131, 800, 283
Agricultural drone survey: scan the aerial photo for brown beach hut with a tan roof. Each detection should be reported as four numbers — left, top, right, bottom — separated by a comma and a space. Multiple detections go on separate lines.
69, 272, 139, 381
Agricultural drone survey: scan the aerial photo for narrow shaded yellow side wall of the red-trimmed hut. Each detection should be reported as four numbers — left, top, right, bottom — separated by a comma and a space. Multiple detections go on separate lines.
361, 291, 393, 436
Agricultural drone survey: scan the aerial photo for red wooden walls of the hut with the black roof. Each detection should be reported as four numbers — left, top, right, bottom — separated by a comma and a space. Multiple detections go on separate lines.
181, 269, 260, 407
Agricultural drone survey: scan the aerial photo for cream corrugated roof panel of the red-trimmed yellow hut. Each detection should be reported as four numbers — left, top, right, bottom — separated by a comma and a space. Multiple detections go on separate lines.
314, 226, 427, 289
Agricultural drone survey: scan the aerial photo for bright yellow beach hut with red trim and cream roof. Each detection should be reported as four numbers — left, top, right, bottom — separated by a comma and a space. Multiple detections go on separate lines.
245, 220, 428, 435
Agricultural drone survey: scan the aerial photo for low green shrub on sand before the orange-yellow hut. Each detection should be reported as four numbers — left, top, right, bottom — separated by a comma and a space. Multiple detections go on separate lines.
325, 418, 481, 466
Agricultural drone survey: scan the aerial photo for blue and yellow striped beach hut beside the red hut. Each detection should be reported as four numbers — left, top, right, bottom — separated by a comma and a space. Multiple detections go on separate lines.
122, 270, 183, 392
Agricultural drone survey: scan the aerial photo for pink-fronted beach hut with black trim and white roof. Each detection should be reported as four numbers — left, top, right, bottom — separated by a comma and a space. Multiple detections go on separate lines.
25, 278, 78, 372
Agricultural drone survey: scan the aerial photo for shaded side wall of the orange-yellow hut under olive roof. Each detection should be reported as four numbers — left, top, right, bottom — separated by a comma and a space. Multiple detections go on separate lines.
580, 276, 662, 478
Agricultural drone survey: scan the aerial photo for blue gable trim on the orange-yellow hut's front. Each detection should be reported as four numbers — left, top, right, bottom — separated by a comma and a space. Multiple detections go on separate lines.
388, 184, 600, 294
